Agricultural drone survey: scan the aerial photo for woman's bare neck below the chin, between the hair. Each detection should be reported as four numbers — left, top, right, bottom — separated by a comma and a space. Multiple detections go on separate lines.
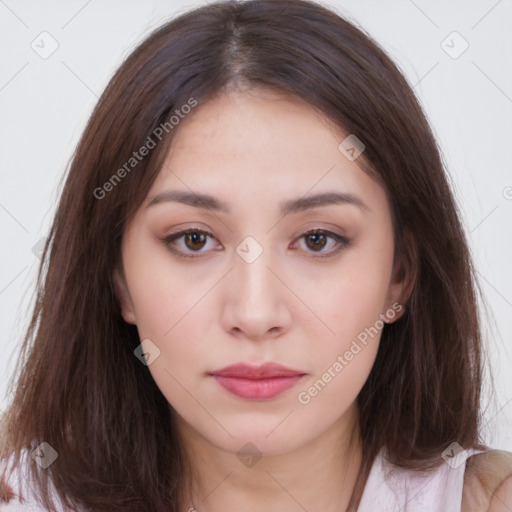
181, 408, 362, 512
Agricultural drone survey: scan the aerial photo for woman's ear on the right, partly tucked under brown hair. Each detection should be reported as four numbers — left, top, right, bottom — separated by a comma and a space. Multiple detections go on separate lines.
384, 231, 418, 323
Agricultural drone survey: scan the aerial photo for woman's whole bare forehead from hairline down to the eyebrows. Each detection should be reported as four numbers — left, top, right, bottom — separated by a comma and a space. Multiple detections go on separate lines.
142, 89, 390, 216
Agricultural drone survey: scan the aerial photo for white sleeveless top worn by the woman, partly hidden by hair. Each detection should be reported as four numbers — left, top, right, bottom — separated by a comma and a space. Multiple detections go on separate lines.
0, 443, 481, 512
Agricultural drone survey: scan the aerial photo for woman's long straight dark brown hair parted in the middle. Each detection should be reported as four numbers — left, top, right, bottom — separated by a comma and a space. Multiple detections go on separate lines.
2, 0, 488, 512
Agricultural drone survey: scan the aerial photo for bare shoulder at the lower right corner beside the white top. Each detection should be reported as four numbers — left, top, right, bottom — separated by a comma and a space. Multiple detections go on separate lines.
462, 450, 512, 512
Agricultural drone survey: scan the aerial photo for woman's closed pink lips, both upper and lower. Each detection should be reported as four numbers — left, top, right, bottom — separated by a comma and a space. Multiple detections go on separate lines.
210, 363, 305, 400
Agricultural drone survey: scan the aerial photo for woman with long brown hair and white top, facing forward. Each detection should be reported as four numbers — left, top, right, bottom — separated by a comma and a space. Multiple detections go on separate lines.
2, 0, 512, 512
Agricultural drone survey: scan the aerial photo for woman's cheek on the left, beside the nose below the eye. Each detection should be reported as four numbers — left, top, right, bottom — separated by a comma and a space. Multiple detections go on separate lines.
123, 242, 215, 390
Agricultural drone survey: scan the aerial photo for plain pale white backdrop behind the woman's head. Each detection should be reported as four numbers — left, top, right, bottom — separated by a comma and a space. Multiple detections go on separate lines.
0, 0, 512, 451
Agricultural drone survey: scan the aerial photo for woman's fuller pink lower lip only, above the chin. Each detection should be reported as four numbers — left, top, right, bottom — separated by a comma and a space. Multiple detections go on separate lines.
214, 375, 302, 400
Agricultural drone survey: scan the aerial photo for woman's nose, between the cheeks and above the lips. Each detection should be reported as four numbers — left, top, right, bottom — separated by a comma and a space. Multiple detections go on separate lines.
222, 247, 293, 341
